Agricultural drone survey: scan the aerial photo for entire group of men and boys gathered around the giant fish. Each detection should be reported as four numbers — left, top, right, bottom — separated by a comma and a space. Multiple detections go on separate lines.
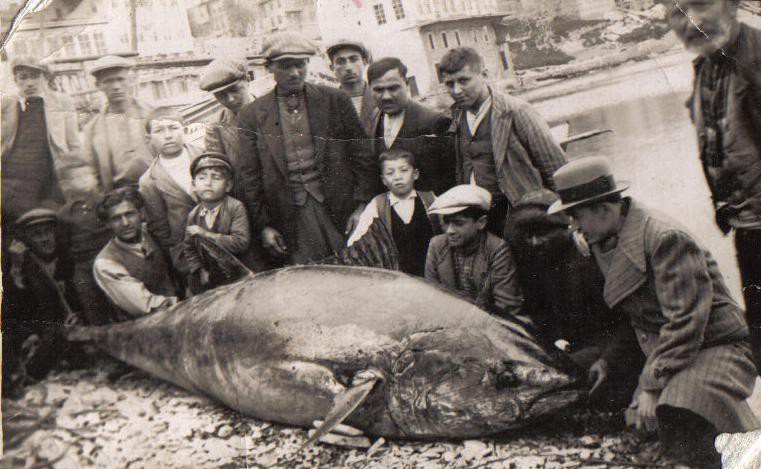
2, 0, 761, 465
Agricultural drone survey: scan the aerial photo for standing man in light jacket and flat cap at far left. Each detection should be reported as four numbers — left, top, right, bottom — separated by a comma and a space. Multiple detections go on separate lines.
1, 57, 93, 230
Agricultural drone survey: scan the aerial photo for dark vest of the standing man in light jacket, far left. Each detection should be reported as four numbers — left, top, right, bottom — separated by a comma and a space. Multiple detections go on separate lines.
2, 98, 55, 223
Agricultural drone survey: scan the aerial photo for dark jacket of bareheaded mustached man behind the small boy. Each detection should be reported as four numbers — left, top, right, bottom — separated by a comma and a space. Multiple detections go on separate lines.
371, 100, 455, 195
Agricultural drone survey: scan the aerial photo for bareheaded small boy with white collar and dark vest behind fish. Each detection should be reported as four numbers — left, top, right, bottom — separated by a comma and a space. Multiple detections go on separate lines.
347, 150, 441, 277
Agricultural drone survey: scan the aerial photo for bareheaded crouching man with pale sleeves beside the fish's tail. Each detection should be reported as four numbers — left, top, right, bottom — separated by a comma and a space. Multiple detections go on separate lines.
93, 187, 177, 321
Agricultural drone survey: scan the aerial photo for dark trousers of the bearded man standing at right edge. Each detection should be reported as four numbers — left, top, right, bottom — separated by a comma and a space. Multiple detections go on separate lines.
735, 229, 761, 371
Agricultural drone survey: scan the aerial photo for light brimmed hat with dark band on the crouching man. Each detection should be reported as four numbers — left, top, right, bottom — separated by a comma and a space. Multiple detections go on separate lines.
547, 156, 629, 215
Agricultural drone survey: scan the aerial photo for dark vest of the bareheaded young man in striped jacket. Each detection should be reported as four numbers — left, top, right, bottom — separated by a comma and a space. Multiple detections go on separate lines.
457, 110, 504, 198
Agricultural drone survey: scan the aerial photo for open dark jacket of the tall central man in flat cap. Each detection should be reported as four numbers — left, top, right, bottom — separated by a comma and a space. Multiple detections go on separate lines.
239, 83, 378, 244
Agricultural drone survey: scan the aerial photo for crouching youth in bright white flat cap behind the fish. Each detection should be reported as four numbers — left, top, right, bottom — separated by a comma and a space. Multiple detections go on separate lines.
425, 184, 525, 322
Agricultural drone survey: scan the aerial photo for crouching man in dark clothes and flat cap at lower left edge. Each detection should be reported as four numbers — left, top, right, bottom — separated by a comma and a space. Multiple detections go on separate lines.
2, 207, 79, 396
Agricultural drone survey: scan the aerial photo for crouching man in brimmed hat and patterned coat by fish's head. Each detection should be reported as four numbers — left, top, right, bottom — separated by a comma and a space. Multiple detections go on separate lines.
548, 157, 758, 467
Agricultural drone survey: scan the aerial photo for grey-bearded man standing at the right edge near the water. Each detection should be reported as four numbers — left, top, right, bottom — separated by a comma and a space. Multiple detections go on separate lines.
667, 0, 761, 370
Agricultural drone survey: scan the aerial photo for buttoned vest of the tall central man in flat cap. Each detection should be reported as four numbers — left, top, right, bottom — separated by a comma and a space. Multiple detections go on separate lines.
277, 95, 325, 206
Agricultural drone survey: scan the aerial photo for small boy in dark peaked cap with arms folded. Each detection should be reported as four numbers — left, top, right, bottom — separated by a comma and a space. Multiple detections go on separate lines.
184, 152, 251, 294
